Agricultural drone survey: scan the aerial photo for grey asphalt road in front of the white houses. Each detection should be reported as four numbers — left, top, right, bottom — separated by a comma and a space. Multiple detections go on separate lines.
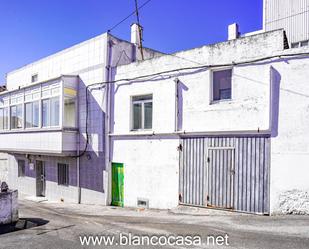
0, 200, 309, 249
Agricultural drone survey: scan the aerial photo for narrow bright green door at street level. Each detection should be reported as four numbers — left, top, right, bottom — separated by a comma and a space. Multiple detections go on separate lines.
112, 163, 124, 207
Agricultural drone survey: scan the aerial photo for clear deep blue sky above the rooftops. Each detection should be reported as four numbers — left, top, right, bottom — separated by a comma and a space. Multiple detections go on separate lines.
0, 0, 263, 85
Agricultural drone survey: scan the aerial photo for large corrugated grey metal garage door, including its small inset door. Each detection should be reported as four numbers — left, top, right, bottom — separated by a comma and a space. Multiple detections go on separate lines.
179, 136, 270, 214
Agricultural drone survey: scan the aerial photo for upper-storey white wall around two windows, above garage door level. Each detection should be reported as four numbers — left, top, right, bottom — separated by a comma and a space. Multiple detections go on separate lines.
114, 31, 283, 134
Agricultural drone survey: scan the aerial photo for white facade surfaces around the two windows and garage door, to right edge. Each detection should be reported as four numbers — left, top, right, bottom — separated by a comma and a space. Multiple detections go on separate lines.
111, 31, 309, 213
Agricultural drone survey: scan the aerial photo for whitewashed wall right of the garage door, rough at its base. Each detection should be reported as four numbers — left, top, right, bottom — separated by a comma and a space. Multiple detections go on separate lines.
270, 52, 309, 214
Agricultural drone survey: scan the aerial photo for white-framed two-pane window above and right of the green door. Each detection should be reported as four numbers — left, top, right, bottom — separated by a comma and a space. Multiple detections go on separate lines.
131, 94, 152, 130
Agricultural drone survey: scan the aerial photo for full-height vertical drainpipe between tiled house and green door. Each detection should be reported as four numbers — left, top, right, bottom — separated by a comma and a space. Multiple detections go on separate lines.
103, 34, 112, 205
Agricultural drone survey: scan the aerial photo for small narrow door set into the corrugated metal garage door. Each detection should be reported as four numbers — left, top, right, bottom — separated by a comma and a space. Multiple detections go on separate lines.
207, 147, 235, 209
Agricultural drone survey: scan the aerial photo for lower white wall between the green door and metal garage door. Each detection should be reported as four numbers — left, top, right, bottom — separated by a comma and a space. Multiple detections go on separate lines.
113, 138, 179, 209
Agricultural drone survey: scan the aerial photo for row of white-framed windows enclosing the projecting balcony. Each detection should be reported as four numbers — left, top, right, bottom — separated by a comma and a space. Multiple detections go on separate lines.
0, 80, 78, 132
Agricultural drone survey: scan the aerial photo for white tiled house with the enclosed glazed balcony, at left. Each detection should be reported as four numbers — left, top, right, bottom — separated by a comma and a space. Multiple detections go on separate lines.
0, 24, 160, 204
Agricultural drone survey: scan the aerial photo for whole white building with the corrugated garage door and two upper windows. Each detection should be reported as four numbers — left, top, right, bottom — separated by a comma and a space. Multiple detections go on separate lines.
110, 30, 309, 214
